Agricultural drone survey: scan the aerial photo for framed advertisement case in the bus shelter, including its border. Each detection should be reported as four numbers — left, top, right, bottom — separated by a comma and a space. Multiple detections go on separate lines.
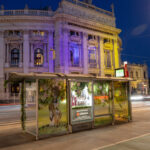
69, 79, 94, 125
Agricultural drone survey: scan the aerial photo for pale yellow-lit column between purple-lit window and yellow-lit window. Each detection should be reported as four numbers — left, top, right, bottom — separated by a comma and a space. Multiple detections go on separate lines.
100, 37, 105, 77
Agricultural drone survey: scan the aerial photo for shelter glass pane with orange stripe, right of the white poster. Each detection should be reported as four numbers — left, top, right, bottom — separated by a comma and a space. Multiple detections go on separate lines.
93, 81, 112, 126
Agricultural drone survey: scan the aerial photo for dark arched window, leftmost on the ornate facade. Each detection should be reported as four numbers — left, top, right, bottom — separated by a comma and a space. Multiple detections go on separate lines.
11, 49, 19, 66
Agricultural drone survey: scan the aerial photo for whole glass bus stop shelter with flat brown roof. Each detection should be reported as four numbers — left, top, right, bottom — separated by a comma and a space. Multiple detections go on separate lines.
9, 73, 132, 140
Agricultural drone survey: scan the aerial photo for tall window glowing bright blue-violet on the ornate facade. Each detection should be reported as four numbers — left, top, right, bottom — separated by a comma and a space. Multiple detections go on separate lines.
69, 42, 80, 67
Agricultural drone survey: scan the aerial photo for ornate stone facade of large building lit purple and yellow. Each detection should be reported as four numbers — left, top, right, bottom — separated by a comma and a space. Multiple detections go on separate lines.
0, 0, 121, 101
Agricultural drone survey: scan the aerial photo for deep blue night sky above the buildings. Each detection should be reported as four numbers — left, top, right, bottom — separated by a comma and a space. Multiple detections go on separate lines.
0, 0, 150, 75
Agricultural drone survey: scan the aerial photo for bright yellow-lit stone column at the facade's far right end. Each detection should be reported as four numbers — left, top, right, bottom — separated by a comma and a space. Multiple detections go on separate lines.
114, 37, 119, 69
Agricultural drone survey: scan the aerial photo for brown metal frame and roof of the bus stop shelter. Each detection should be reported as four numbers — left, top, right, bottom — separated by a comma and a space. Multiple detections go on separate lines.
9, 72, 132, 140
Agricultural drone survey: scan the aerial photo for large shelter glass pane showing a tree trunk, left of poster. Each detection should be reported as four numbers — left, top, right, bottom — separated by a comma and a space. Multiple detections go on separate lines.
38, 79, 67, 135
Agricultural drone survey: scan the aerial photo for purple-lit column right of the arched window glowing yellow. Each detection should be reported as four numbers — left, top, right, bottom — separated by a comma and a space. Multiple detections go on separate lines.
47, 31, 54, 72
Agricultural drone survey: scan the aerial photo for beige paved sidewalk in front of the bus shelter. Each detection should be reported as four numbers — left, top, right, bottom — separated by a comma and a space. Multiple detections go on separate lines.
0, 108, 150, 150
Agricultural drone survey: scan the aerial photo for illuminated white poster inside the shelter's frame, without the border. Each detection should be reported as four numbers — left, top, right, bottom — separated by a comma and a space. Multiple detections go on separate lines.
71, 82, 93, 123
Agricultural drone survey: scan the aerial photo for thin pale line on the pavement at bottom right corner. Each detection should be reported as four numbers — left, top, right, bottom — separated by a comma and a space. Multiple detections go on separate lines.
92, 133, 150, 150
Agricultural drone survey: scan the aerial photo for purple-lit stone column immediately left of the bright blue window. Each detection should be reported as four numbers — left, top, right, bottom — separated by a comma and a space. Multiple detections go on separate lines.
63, 29, 69, 74
